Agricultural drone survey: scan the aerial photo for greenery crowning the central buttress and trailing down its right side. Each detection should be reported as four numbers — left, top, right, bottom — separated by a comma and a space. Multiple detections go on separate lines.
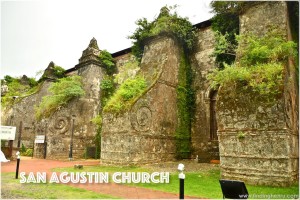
123, 6, 196, 159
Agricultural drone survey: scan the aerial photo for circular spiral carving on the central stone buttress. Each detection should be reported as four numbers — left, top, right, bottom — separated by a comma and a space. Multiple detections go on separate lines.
131, 106, 152, 131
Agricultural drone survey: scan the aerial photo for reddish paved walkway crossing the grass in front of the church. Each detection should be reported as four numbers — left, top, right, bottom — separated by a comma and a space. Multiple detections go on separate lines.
1, 158, 199, 199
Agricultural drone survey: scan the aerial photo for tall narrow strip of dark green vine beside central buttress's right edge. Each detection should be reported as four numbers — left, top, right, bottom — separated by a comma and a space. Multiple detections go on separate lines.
175, 51, 195, 159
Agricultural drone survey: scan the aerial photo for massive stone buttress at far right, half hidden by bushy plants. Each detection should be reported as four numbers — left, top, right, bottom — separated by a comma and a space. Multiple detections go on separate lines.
217, 1, 299, 186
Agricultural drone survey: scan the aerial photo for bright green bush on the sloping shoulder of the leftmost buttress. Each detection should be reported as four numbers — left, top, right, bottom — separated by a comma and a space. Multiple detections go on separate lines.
35, 76, 84, 120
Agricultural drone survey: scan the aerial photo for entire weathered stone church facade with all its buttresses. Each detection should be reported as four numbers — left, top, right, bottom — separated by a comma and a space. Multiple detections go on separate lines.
1, 2, 299, 185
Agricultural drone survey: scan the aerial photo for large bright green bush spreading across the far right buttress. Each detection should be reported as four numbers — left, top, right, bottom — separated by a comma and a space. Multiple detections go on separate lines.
208, 28, 297, 101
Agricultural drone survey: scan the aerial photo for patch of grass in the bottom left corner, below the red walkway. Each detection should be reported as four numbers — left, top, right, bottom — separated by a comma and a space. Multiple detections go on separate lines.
1, 172, 118, 199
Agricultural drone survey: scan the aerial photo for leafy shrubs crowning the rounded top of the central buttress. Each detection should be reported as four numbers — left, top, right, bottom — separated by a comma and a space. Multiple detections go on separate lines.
129, 5, 196, 60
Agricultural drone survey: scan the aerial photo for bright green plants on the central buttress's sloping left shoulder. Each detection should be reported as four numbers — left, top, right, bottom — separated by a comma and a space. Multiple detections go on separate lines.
103, 76, 147, 114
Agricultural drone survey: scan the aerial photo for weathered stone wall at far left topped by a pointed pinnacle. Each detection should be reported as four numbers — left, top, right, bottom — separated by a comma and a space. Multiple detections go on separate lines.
1, 39, 105, 159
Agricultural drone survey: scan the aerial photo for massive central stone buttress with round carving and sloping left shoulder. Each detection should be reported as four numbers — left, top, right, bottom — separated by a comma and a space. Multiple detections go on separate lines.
101, 36, 182, 165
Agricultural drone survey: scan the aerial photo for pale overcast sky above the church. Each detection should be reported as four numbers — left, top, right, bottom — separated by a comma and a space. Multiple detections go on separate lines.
1, 0, 213, 78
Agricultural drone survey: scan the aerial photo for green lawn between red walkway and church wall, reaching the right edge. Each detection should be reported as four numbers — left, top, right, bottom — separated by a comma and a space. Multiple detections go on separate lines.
53, 166, 299, 199
